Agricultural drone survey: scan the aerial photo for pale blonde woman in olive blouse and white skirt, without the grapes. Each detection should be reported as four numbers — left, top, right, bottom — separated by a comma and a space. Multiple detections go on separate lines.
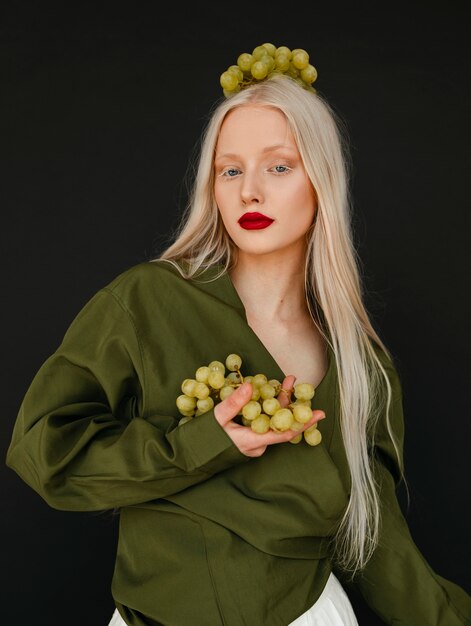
7, 44, 471, 626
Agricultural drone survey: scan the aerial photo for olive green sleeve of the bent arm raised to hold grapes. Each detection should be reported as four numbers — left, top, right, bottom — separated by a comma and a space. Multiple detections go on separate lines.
6, 289, 248, 511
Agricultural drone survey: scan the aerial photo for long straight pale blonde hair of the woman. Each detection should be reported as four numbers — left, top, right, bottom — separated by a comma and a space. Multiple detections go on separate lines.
157, 75, 403, 574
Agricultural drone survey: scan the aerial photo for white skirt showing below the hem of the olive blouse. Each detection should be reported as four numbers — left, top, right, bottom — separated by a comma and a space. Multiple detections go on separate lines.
108, 574, 358, 626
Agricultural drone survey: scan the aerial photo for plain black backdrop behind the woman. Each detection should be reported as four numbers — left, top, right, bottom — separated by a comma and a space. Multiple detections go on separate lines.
0, 2, 471, 626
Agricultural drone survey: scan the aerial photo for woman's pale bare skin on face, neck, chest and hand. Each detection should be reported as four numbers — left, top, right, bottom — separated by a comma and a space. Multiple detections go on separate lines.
214, 105, 327, 457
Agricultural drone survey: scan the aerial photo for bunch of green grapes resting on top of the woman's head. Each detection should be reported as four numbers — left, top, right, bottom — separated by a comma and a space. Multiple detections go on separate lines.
219, 43, 317, 98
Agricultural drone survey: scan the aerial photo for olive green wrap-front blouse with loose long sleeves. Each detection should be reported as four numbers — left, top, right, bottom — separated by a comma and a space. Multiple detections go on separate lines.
6, 260, 471, 626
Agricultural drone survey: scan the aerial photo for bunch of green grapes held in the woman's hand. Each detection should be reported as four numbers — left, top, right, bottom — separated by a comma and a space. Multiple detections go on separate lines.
176, 354, 322, 446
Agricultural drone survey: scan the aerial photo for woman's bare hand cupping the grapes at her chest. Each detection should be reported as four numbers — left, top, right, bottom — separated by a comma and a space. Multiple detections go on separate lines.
214, 376, 325, 457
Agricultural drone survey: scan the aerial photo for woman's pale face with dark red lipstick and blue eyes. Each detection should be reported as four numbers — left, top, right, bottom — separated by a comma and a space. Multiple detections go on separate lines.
214, 105, 317, 255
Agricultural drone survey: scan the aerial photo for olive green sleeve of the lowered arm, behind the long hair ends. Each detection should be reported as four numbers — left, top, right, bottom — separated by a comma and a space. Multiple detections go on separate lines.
342, 354, 471, 626
